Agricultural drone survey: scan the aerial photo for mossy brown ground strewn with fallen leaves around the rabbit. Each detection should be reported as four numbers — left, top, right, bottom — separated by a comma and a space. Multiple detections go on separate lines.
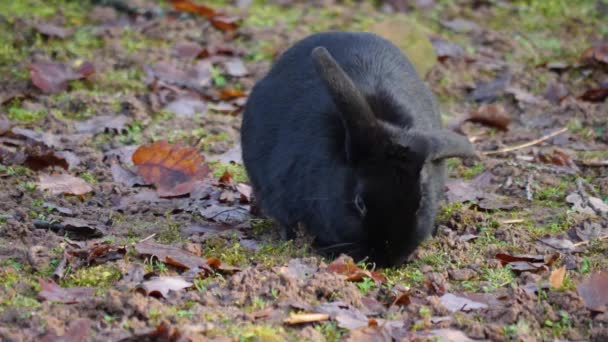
0, 0, 608, 341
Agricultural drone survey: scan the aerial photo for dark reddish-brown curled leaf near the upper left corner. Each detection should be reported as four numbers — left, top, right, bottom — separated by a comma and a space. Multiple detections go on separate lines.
29, 62, 95, 93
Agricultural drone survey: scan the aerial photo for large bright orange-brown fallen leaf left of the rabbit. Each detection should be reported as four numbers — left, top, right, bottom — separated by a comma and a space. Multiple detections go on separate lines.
132, 140, 209, 197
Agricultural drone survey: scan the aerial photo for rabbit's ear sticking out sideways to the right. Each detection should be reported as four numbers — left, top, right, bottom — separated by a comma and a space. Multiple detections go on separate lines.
425, 129, 479, 160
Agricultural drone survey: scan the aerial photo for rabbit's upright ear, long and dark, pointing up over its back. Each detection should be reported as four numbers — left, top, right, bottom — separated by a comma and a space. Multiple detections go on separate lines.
312, 46, 378, 161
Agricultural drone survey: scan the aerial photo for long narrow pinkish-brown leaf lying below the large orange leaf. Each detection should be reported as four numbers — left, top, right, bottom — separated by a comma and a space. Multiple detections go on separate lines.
133, 241, 213, 273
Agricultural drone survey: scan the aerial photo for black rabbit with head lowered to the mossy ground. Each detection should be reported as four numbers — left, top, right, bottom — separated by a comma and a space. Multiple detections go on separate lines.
242, 32, 475, 266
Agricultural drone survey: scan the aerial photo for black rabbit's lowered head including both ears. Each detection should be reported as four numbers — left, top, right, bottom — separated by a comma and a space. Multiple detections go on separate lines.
312, 47, 475, 264
